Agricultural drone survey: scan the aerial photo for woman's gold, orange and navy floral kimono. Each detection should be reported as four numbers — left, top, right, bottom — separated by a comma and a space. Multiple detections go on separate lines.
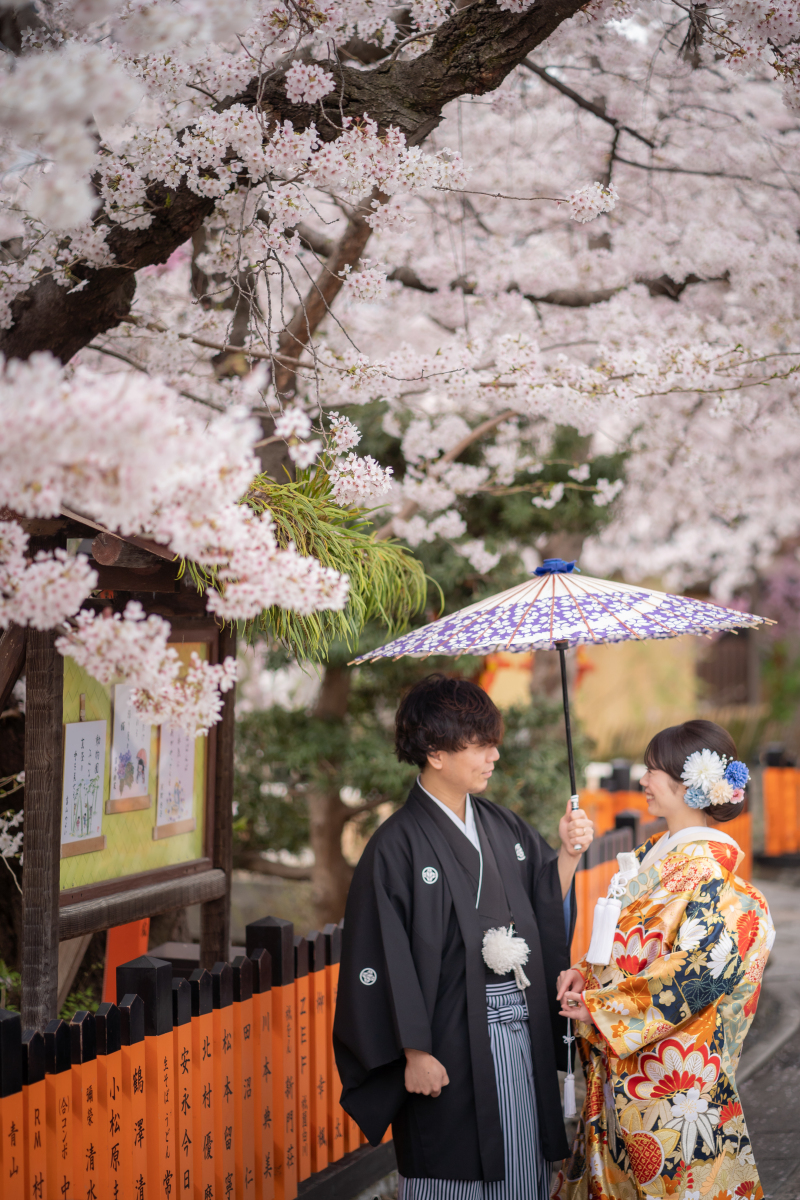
553, 830, 775, 1200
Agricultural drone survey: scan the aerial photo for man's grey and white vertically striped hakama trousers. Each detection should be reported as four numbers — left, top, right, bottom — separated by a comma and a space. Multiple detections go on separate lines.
397, 980, 551, 1200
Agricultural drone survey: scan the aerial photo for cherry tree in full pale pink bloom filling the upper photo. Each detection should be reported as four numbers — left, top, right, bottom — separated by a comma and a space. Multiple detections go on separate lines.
0, 0, 800, 916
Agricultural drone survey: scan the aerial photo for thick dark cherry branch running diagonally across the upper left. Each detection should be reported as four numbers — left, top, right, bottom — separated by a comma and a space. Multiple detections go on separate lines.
0, 0, 584, 361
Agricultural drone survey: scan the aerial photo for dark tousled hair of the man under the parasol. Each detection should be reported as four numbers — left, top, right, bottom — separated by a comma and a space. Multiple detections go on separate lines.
395, 674, 503, 767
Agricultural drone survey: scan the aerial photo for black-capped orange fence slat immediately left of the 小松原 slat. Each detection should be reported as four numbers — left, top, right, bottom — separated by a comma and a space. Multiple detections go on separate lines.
70, 1009, 101, 1200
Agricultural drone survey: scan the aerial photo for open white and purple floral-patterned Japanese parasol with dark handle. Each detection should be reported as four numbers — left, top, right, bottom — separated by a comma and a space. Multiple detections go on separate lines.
354, 558, 765, 809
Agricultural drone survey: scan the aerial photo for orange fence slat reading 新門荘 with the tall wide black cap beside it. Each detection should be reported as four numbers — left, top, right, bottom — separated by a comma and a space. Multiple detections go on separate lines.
247, 917, 297, 1200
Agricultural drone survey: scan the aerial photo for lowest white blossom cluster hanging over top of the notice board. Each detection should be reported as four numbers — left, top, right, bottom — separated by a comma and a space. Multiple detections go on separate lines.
55, 600, 236, 737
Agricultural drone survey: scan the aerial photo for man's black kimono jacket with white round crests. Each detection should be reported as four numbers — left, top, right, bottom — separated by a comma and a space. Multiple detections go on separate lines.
333, 784, 575, 1182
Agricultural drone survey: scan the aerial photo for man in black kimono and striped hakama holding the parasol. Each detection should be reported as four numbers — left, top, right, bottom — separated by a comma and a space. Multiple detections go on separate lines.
333, 674, 593, 1200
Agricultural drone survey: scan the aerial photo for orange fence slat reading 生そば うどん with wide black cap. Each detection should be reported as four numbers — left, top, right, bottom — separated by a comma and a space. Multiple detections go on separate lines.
116, 954, 178, 1200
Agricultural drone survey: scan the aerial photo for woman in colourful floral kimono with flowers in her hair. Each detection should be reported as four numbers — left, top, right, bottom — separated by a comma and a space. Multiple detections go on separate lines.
552, 721, 775, 1200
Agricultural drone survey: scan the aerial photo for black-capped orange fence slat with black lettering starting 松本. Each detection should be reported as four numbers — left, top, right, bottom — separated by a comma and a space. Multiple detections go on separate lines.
211, 962, 236, 1200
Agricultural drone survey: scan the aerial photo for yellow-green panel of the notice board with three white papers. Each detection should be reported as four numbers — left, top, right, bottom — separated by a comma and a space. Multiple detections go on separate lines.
60, 622, 218, 906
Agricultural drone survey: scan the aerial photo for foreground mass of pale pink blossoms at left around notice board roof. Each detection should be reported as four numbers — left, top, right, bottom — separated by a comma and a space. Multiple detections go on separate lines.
0, 355, 348, 728
